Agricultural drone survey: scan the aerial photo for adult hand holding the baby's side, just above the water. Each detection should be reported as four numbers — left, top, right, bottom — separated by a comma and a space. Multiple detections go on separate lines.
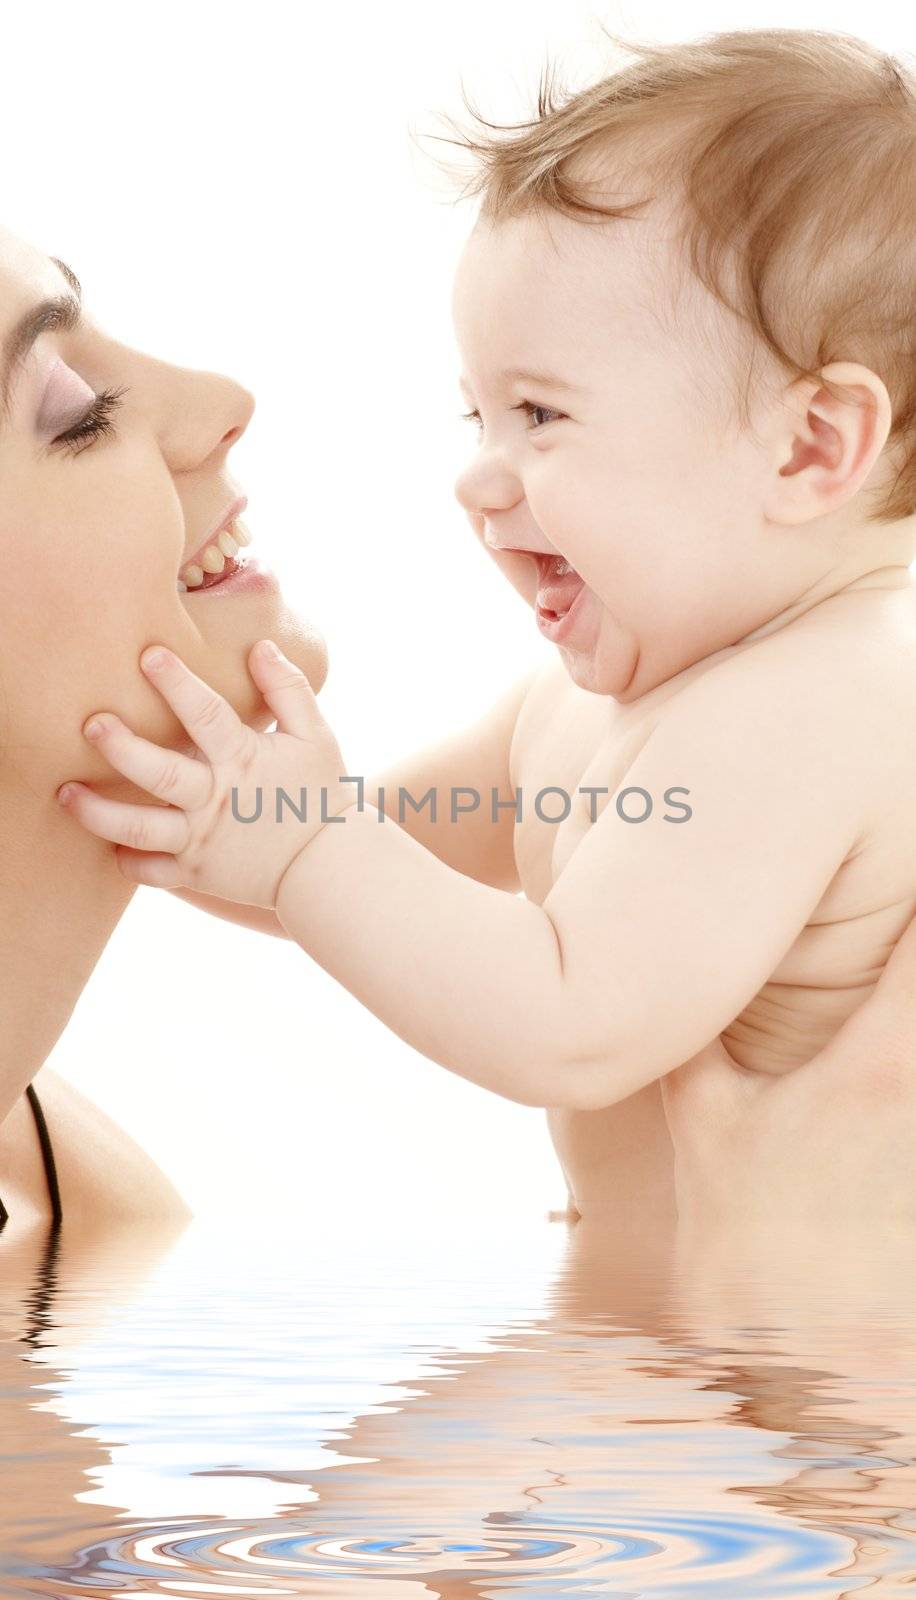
661, 918, 916, 1266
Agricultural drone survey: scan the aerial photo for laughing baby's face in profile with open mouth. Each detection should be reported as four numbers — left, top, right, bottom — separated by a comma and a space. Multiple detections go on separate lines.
453, 204, 780, 701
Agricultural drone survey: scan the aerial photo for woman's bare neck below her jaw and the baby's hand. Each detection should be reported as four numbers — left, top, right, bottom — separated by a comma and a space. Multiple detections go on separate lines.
0, 780, 136, 1123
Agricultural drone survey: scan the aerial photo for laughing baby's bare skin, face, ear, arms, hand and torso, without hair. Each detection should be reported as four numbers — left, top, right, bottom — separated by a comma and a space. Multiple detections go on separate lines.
53, 200, 916, 1213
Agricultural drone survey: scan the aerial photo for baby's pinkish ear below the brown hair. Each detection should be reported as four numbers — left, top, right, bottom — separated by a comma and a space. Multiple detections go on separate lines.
762, 362, 892, 526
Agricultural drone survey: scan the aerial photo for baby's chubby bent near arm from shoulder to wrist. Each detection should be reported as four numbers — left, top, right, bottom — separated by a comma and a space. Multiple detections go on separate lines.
277, 638, 879, 1109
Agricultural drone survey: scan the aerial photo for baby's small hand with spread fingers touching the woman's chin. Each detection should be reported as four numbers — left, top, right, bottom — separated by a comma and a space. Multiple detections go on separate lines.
58, 640, 359, 907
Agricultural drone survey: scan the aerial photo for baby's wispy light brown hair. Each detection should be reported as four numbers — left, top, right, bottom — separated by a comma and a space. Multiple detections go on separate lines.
419, 29, 916, 522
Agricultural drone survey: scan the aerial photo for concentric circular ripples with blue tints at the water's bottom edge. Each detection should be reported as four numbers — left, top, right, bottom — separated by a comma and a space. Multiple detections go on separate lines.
1, 1514, 849, 1600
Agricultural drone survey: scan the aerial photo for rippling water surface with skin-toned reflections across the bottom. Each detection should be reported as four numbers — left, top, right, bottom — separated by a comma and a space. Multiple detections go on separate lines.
0, 1219, 916, 1600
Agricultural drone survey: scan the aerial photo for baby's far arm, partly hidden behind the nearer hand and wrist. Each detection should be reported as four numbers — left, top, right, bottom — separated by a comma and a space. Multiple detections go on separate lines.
171, 664, 543, 939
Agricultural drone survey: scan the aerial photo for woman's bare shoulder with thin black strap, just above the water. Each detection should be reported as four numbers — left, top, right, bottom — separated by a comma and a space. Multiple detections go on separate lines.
3, 1066, 192, 1229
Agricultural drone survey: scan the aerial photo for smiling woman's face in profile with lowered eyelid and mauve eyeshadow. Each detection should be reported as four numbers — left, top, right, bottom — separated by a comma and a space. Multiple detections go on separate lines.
0, 229, 327, 802
